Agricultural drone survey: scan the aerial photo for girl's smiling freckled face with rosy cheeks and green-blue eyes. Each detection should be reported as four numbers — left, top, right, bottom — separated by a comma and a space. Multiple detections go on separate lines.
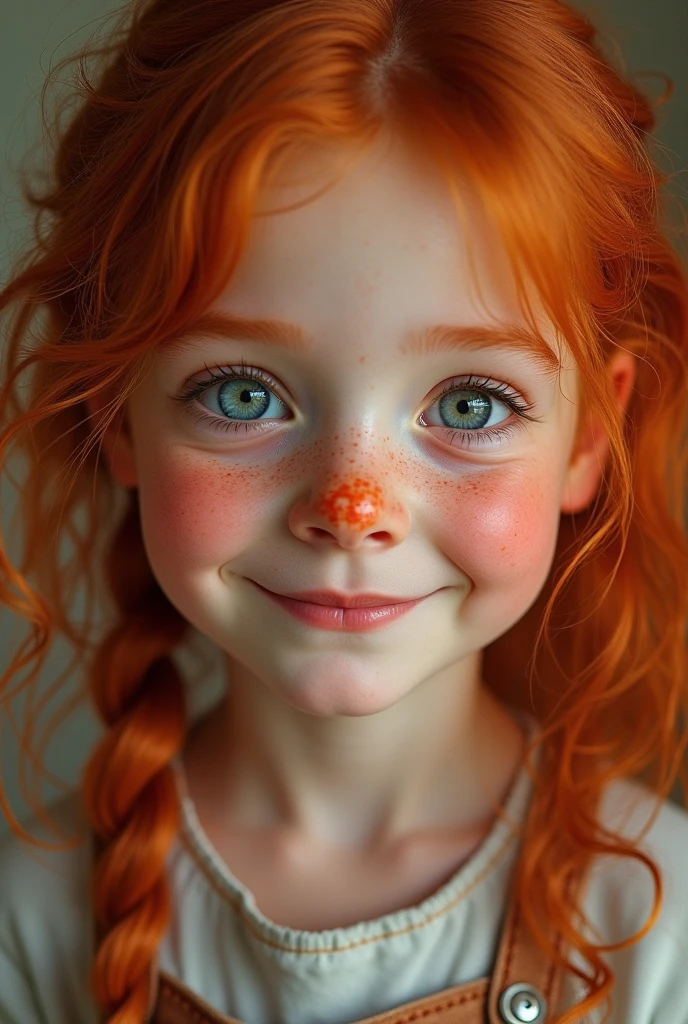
96, 132, 595, 716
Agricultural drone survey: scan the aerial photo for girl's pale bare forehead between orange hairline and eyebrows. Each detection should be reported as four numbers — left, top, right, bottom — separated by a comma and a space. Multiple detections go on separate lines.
229, 134, 499, 303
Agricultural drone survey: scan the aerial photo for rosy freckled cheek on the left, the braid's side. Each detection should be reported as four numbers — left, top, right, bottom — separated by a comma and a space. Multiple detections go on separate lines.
139, 452, 273, 570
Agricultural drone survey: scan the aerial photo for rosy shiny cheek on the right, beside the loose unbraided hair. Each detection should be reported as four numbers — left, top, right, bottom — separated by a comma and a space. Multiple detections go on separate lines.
436, 465, 559, 591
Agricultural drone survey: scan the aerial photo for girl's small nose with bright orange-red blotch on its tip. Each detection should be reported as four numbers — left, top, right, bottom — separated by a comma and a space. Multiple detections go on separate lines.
289, 474, 410, 551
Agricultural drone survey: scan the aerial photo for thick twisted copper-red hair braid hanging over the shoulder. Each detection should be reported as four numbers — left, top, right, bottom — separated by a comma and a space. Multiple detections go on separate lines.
82, 492, 188, 1024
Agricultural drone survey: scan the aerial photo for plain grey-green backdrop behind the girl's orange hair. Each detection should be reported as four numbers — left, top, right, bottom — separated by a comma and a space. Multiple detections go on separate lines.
0, 0, 688, 836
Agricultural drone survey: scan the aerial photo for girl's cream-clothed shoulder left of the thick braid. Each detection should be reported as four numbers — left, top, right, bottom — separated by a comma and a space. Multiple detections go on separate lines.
0, 792, 97, 1024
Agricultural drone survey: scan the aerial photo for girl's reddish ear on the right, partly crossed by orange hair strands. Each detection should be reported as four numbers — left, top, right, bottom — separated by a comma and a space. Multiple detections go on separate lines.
561, 352, 636, 512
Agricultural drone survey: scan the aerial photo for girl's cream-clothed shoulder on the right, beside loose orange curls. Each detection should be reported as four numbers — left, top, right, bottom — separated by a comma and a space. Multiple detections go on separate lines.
565, 779, 688, 1024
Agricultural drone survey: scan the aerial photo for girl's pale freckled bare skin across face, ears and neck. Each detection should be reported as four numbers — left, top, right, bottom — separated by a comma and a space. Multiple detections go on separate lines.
91, 132, 634, 927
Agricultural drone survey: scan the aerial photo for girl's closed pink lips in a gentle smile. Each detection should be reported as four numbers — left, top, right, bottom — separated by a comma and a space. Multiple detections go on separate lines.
249, 580, 429, 633
